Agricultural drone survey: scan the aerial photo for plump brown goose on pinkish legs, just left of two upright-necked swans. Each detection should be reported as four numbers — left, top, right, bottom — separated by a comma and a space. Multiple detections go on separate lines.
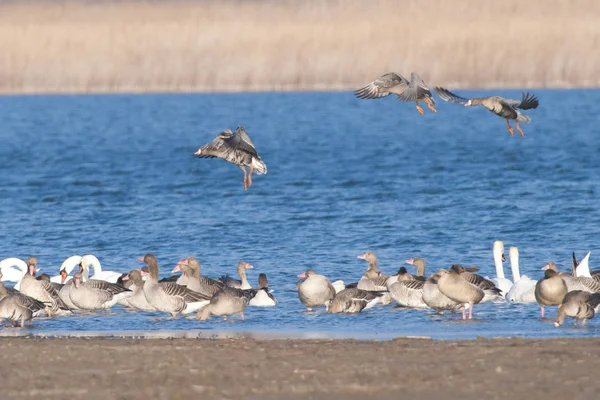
438, 265, 485, 319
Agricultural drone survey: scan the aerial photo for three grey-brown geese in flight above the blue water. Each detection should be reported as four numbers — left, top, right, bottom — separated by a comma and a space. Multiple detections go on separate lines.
194, 77, 539, 190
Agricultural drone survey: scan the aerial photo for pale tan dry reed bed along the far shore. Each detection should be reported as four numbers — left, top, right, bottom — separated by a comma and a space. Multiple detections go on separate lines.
0, 0, 600, 93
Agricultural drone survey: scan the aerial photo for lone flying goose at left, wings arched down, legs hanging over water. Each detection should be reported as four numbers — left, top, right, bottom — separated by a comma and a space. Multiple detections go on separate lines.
194, 126, 267, 190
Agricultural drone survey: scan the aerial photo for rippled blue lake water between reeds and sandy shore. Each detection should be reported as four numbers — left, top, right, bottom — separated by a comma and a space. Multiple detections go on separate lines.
0, 90, 600, 338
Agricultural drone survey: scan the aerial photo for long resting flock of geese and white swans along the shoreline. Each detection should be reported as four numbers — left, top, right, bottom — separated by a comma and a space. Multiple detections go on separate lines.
0, 241, 600, 327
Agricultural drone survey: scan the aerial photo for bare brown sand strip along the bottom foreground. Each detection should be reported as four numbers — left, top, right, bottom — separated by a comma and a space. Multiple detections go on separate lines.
0, 338, 600, 400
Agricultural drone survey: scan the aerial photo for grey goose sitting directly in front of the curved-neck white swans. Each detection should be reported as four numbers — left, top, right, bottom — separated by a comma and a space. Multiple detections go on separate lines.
69, 264, 133, 311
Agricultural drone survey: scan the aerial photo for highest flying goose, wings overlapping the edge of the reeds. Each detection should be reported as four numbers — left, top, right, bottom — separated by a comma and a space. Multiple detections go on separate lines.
354, 72, 437, 115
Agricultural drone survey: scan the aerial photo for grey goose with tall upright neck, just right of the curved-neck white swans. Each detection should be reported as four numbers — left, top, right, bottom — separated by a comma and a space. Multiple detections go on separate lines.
138, 254, 210, 317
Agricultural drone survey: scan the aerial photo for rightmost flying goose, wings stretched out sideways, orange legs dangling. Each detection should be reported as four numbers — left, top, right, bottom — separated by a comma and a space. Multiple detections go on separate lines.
435, 87, 540, 136
